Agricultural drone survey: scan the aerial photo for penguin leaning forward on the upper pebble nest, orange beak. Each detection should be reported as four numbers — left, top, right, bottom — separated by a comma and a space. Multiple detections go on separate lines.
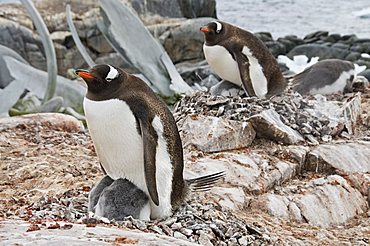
200, 21, 287, 98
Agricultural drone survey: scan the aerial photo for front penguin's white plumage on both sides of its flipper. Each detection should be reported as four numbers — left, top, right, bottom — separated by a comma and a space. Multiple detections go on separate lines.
84, 98, 173, 218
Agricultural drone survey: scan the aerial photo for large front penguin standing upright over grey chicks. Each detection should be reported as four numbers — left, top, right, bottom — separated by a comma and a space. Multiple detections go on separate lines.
76, 64, 224, 219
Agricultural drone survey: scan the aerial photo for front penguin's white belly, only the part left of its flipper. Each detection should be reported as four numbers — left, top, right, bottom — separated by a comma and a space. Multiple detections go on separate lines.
84, 98, 148, 194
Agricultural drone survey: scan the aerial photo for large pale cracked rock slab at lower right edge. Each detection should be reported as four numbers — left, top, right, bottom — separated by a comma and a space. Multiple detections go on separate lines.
252, 175, 368, 227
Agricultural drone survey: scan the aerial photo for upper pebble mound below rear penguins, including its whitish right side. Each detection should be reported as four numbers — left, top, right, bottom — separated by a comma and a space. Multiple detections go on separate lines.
174, 87, 370, 144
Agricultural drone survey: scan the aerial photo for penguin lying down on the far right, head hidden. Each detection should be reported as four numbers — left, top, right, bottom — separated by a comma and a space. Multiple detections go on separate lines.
292, 59, 355, 95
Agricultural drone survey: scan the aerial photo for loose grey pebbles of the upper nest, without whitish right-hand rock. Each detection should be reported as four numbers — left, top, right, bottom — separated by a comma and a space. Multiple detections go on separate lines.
174, 92, 364, 144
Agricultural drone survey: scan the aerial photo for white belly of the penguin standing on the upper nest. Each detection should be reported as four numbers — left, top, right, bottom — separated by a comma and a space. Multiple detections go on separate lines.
203, 44, 242, 86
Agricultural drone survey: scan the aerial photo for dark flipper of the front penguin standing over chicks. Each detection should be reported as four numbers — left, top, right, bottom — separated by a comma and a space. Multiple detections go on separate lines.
139, 119, 159, 206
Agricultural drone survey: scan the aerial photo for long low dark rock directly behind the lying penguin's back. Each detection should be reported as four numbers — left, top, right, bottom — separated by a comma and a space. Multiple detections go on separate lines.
287, 44, 350, 60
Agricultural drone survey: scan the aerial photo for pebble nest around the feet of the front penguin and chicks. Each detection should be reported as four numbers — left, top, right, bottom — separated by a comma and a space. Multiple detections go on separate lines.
11, 187, 271, 246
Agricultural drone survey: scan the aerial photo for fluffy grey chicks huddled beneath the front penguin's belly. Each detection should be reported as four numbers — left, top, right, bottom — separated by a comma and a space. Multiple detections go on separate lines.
95, 178, 150, 221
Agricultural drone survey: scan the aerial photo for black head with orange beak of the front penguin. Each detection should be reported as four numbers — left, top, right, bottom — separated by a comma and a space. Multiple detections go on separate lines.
76, 64, 125, 96
